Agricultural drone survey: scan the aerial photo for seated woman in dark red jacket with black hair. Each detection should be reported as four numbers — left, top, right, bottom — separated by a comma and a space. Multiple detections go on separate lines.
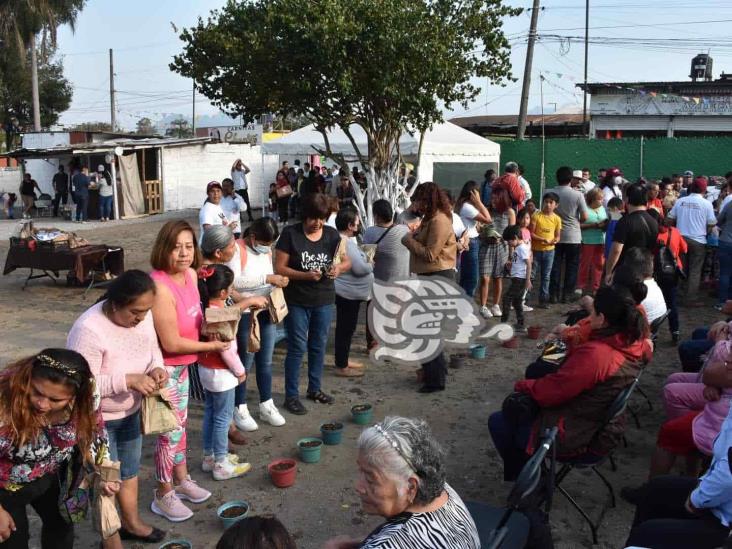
488, 286, 652, 481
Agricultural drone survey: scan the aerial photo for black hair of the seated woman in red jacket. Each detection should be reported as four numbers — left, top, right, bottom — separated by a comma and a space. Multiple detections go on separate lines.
594, 284, 648, 344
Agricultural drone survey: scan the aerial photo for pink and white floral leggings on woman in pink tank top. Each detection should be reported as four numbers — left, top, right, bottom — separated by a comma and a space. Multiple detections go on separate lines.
155, 364, 189, 482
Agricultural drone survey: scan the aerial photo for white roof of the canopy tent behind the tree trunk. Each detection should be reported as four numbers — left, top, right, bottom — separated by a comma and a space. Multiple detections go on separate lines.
262, 122, 501, 161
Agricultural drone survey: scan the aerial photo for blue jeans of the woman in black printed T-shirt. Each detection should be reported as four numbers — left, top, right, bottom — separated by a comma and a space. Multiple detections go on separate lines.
285, 305, 333, 398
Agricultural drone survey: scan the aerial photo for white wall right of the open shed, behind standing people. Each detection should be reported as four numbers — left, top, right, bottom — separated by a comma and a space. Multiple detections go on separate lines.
162, 143, 277, 212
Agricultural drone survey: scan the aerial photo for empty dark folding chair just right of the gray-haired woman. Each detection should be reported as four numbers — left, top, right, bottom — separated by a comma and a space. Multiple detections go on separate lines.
465, 427, 557, 549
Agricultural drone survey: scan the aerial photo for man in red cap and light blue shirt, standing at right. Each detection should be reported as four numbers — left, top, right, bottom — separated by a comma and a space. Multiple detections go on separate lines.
666, 176, 717, 300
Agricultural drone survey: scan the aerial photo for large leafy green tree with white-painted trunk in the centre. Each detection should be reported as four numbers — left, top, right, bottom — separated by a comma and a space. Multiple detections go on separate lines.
171, 0, 520, 223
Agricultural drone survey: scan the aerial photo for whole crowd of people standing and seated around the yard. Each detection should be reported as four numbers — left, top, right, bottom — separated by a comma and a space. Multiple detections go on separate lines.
7, 155, 732, 549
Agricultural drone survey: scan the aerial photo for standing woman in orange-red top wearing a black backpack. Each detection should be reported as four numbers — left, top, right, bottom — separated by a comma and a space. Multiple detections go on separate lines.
647, 208, 688, 344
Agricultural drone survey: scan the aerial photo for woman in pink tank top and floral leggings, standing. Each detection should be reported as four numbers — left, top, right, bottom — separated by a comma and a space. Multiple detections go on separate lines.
150, 220, 229, 522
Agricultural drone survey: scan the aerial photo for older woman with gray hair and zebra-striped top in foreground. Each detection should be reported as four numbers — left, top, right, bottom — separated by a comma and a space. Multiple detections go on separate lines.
324, 416, 480, 549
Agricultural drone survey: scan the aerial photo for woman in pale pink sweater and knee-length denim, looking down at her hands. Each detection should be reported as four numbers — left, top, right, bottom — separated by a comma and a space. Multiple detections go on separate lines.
66, 270, 168, 543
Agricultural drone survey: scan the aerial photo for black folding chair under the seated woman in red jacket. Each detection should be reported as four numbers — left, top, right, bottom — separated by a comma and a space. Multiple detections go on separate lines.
554, 378, 638, 544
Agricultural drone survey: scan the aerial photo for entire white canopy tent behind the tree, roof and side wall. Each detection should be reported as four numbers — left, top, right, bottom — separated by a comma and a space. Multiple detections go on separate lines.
262, 122, 501, 186
